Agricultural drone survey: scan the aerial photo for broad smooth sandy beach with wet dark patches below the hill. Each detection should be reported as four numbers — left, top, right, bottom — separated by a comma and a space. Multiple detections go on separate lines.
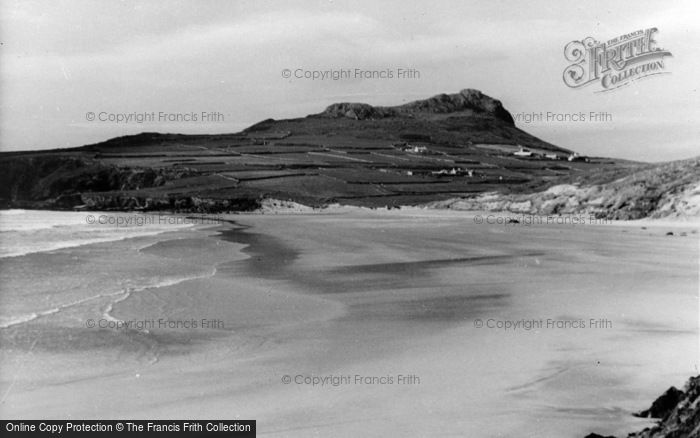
0, 208, 699, 437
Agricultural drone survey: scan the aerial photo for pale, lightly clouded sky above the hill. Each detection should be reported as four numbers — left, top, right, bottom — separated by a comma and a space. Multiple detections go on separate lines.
0, 0, 700, 162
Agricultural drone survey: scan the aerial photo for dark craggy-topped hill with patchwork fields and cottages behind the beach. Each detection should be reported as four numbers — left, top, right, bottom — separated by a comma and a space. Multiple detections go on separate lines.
0, 89, 700, 219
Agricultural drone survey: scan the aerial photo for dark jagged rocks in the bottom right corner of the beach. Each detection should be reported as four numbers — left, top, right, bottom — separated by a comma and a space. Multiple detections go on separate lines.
586, 376, 700, 438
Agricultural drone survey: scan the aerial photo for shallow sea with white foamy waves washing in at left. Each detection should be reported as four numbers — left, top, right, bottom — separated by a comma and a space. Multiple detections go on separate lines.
0, 210, 228, 328
